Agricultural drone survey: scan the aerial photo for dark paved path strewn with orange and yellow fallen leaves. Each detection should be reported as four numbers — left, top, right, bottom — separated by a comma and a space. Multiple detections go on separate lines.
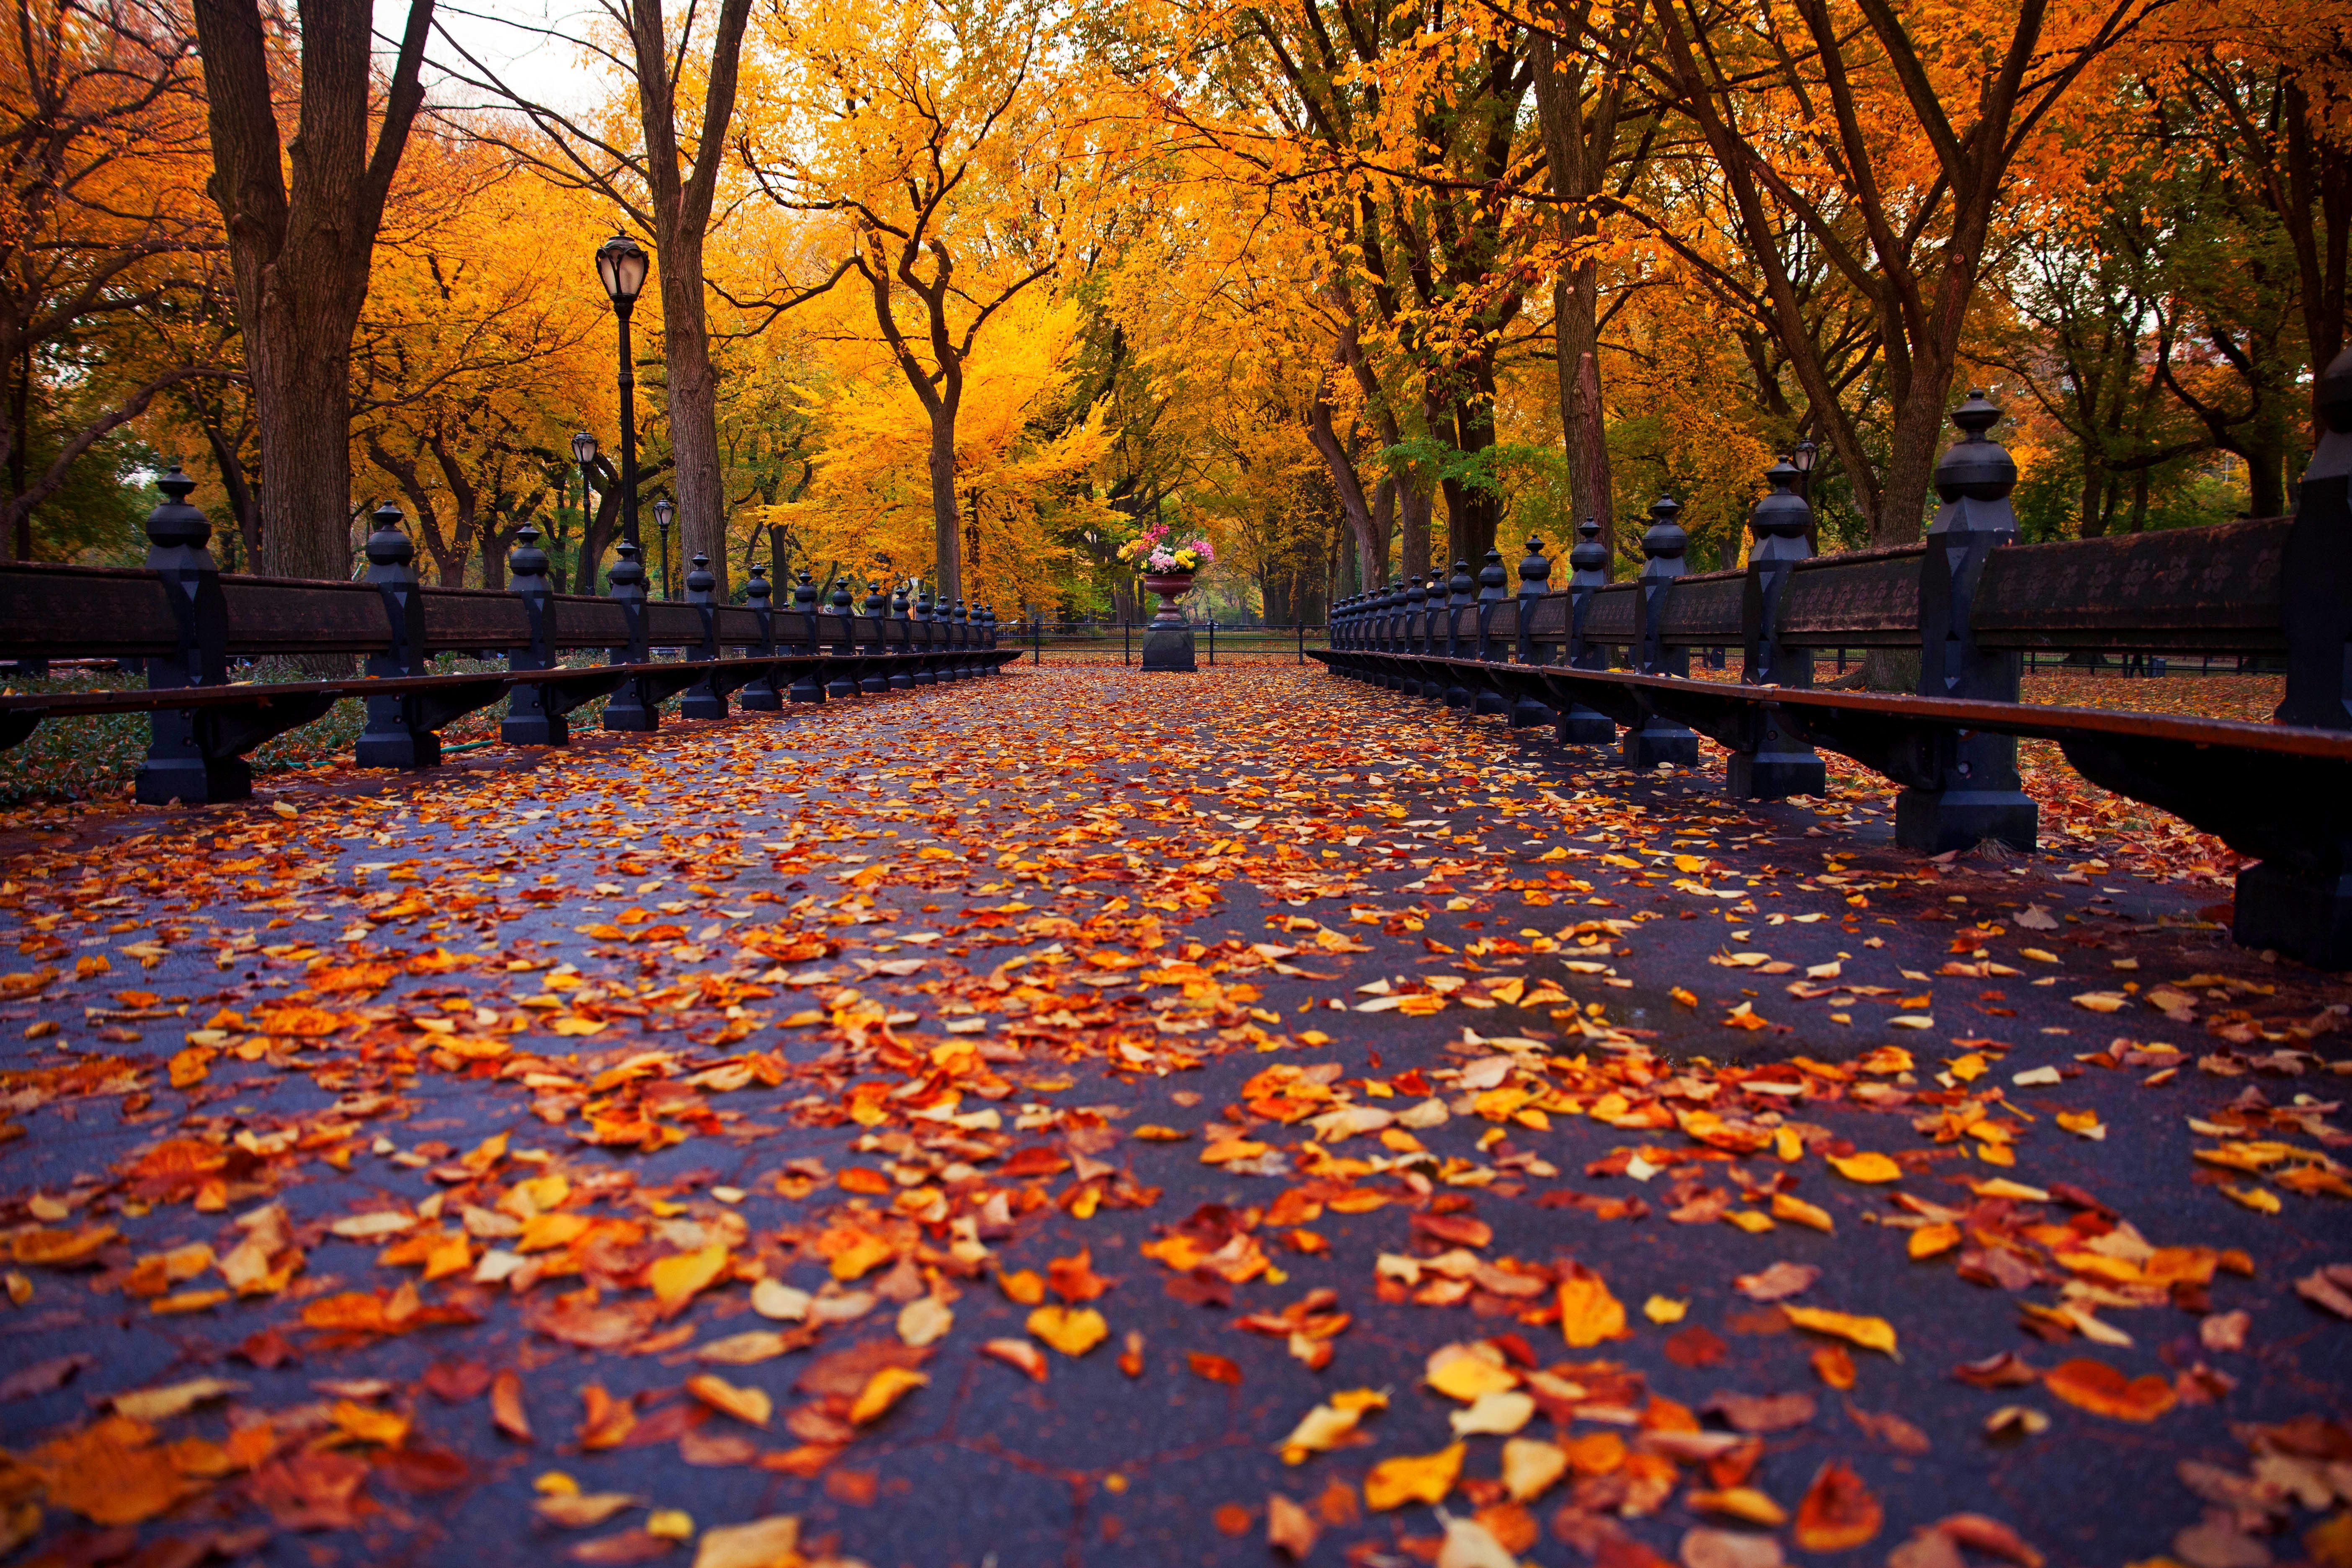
0, 668, 2352, 1568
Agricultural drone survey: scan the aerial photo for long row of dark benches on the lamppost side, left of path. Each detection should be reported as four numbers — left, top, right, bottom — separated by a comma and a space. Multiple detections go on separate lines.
0, 480, 1021, 804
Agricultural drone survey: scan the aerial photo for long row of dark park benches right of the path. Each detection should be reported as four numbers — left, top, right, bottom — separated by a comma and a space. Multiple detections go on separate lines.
1315, 371, 2352, 969
